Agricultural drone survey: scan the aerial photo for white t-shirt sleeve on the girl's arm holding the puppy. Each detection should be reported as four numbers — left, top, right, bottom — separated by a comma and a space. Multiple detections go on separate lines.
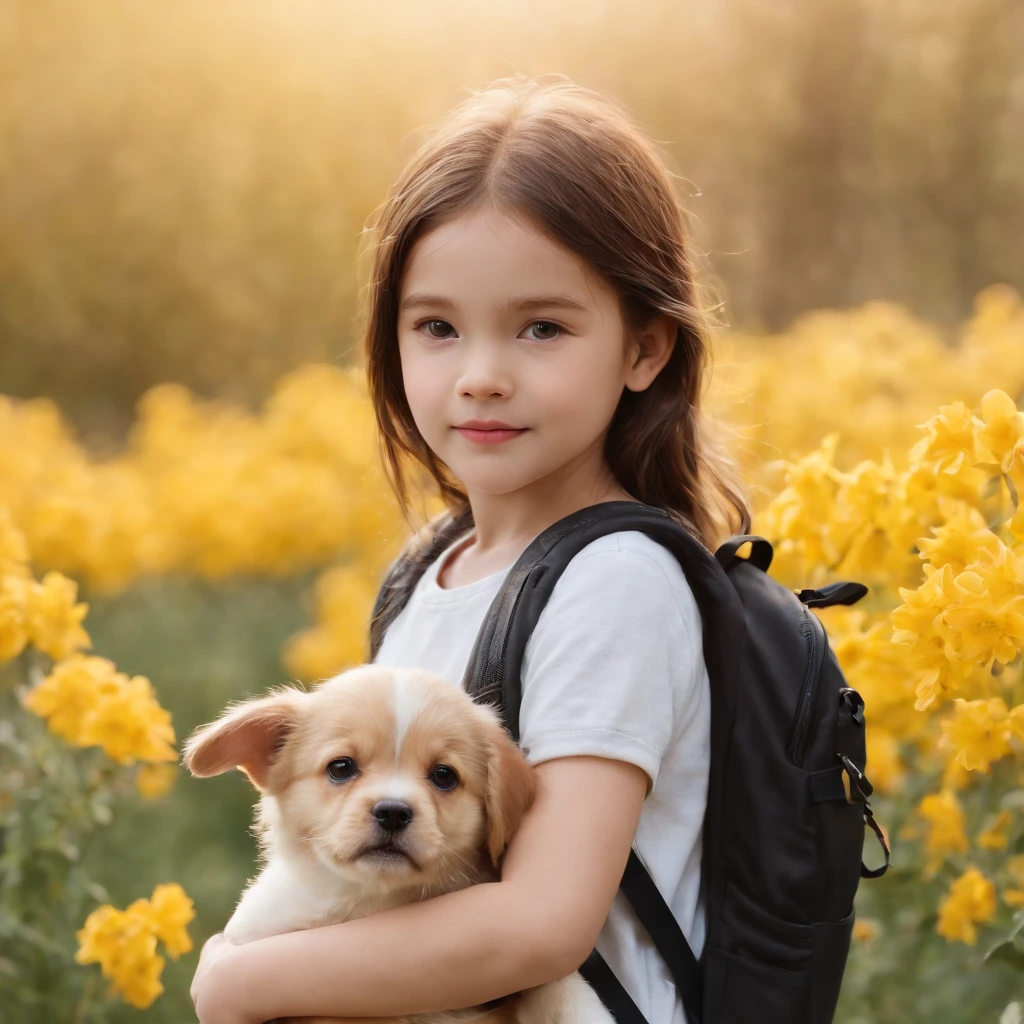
519, 534, 699, 793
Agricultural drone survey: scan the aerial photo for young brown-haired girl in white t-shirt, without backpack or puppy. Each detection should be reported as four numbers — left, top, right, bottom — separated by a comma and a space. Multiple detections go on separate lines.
193, 77, 750, 1024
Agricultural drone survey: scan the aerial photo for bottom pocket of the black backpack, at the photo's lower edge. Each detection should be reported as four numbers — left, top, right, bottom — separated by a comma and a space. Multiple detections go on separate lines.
703, 886, 854, 1024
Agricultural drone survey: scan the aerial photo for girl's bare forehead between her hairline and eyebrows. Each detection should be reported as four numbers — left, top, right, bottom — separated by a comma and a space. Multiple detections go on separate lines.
401, 207, 609, 309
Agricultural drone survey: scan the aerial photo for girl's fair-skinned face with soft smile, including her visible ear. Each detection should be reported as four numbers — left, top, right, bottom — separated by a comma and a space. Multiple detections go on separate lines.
398, 207, 671, 495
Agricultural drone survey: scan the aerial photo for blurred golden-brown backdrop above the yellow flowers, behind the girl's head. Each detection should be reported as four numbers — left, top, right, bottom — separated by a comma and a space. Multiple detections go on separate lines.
8, 0, 1024, 436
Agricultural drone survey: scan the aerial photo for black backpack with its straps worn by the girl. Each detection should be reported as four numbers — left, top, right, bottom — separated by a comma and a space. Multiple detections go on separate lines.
371, 502, 889, 1024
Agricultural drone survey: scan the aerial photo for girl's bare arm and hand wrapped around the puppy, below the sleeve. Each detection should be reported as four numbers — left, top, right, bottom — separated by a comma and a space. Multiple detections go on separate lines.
193, 757, 648, 1024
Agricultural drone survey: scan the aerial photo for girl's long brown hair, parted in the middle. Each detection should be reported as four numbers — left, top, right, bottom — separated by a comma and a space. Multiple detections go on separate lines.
366, 76, 751, 550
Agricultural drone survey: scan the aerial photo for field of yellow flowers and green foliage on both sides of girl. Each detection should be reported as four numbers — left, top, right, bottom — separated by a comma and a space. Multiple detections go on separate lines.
0, 286, 1024, 1024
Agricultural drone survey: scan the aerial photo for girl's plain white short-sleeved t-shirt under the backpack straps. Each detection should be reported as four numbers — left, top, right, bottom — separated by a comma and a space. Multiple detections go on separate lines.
375, 530, 711, 1024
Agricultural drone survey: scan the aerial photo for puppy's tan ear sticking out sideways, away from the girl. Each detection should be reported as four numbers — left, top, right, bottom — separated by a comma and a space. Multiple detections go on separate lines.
182, 687, 306, 791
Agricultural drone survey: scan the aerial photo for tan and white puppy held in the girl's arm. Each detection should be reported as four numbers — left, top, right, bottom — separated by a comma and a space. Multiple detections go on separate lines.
183, 666, 613, 1024
